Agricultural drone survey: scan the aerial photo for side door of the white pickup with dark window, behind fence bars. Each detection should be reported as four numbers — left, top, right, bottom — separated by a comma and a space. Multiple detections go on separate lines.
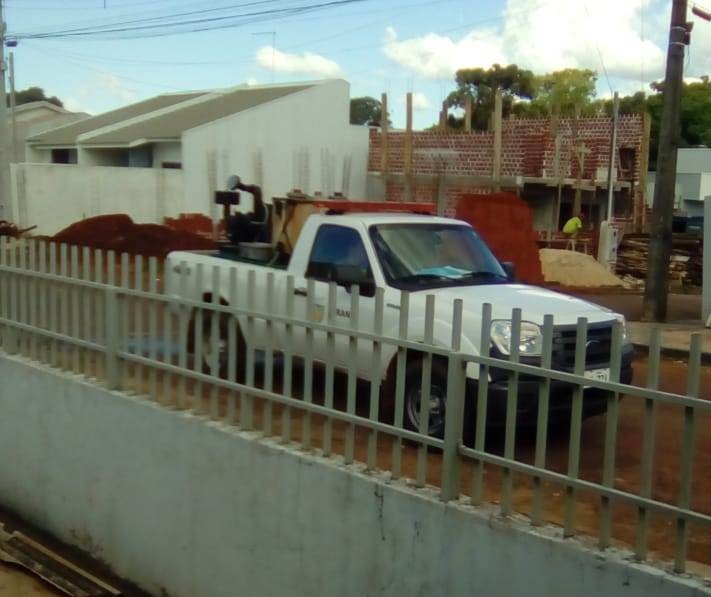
295, 224, 375, 374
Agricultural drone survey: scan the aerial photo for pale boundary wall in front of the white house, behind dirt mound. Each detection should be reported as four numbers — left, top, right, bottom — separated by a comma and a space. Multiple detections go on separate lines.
12, 164, 184, 235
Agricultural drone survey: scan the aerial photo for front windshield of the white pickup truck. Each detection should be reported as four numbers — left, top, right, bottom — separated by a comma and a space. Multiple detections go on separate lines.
370, 224, 508, 290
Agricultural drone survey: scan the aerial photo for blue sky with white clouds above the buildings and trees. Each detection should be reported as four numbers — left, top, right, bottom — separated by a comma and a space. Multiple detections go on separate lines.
0, 0, 711, 128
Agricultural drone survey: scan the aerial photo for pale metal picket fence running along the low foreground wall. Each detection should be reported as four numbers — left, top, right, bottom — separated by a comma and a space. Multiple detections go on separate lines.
0, 238, 711, 572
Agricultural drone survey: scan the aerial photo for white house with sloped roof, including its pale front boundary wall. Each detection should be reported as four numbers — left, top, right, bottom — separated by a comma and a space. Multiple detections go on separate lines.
12, 79, 368, 234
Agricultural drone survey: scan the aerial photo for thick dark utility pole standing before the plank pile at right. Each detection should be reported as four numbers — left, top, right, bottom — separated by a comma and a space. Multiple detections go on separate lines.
642, 0, 690, 321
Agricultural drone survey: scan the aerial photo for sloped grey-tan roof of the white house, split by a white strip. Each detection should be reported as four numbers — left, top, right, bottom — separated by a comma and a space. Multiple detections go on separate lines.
28, 83, 314, 147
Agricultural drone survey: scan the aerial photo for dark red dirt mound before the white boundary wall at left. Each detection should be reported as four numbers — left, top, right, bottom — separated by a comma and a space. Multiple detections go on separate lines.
52, 214, 216, 259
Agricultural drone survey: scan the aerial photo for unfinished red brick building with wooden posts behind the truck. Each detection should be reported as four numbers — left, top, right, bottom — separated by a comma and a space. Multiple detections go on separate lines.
368, 93, 650, 234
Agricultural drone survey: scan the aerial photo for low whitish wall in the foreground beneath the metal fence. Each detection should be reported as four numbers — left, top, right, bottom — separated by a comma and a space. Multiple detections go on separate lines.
0, 355, 709, 597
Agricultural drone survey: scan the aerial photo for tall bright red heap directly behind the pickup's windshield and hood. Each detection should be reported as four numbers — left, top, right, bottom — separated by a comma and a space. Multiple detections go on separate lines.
457, 193, 543, 284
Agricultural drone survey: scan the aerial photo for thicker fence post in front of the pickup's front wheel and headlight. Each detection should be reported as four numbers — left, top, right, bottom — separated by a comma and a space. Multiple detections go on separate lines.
440, 299, 467, 502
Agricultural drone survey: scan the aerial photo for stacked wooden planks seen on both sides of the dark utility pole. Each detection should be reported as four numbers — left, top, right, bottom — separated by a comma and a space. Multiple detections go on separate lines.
616, 234, 704, 286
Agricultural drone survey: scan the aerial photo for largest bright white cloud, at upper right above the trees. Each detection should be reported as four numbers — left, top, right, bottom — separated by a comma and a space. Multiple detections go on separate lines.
383, 0, 672, 87
